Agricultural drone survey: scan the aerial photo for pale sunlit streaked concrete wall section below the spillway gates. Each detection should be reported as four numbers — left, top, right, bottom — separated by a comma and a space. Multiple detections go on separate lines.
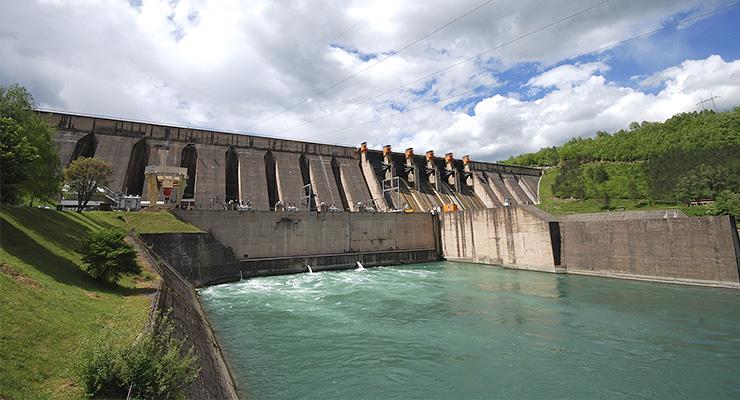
440, 206, 559, 272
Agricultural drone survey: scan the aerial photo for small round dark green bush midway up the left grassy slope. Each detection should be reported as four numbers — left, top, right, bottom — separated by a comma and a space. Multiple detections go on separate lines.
80, 229, 141, 283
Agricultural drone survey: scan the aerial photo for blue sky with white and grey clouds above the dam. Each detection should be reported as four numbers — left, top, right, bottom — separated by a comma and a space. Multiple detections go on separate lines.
0, 0, 740, 161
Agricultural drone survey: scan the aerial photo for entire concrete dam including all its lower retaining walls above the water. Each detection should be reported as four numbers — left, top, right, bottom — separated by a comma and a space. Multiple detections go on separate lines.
40, 112, 740, 288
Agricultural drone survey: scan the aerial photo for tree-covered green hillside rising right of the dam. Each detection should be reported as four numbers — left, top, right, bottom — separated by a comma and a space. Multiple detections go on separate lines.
503, 107, 740, 216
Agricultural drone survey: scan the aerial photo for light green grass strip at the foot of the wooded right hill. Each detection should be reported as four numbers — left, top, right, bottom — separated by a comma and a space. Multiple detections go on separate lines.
538, 168, 704, 215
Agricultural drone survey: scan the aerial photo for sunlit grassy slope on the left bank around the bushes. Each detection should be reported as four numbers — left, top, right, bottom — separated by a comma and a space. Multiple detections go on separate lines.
0, 206, 197, 399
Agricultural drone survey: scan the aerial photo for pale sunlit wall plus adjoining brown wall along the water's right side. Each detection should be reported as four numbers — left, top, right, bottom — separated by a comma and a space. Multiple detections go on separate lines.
440, 206, 740, 288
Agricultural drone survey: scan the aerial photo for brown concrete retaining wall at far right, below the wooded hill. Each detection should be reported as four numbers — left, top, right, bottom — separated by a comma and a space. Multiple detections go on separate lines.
560, 216, 740, 287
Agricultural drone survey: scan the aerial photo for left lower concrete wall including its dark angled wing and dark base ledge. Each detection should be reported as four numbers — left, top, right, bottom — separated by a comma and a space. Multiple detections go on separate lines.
142, 210, 439, 286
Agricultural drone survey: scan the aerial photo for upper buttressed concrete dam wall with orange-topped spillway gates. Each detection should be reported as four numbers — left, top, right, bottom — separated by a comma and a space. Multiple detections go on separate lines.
40, 112, 541, 212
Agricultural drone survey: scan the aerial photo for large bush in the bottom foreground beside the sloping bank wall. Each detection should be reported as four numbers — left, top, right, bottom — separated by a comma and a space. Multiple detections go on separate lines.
78, 317, 199, 399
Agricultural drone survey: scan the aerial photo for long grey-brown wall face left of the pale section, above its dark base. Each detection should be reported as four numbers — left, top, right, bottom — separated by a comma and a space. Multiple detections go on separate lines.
175, 210, 435, 259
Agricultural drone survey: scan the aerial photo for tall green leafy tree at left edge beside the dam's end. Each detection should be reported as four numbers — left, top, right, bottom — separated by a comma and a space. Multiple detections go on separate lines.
0, 85, 62, 204
